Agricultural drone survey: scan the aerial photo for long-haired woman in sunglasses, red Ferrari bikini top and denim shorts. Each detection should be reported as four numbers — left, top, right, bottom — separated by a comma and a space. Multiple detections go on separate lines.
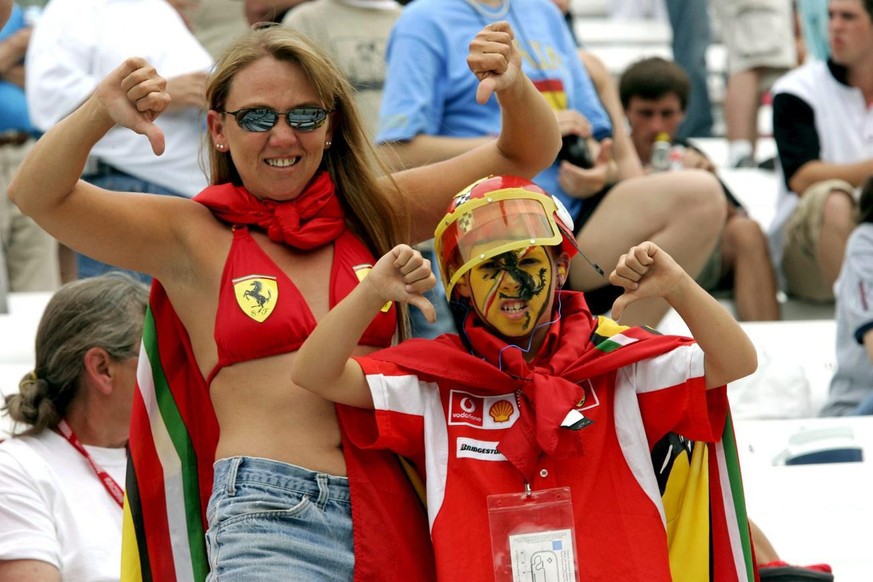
10, 23, 560, 580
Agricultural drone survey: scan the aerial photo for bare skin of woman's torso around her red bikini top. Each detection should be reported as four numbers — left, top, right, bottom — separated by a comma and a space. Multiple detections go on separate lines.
167, 232, 382, 475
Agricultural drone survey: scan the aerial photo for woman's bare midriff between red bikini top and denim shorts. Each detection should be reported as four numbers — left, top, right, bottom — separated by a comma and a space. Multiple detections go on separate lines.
210, 348, 380, 475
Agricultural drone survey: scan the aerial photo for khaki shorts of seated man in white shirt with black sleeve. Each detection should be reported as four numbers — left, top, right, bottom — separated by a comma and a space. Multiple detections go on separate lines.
782, 180, 854, 302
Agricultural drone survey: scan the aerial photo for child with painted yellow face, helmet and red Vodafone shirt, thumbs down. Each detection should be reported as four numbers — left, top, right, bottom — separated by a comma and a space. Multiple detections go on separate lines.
292, 177, 756, 581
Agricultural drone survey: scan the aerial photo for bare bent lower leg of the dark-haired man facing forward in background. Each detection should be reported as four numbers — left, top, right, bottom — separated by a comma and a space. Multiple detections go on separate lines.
721, 214, 780, 321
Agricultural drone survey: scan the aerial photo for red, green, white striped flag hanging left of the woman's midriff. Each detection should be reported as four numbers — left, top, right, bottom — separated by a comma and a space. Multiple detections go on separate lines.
122, 282, 218, 582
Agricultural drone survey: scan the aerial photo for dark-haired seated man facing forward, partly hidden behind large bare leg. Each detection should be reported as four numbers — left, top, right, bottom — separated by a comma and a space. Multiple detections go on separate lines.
619, 57, 779, 321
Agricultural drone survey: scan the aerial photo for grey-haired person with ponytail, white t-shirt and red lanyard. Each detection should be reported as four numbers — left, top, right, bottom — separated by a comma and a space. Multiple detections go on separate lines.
0, 273, 148, 582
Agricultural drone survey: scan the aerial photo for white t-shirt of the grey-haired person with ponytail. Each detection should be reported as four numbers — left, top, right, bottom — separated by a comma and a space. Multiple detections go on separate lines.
0, 430, 127, 582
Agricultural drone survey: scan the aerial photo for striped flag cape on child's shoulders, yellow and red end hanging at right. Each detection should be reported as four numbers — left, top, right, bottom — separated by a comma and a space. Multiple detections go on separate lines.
368, 292, 756, 582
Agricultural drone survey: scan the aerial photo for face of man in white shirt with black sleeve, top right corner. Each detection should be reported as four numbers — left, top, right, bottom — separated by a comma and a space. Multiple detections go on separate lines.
828, 0, 873, 67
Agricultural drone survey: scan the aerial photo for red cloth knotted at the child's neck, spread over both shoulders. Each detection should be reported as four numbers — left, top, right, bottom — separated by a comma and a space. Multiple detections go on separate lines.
368, 291, 693, 481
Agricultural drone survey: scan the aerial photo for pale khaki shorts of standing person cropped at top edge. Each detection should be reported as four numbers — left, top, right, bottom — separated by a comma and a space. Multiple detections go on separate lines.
711, 0, 797, 75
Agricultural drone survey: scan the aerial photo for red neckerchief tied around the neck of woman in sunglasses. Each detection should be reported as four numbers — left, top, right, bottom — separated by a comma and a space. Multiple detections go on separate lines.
194, 172, 346, 250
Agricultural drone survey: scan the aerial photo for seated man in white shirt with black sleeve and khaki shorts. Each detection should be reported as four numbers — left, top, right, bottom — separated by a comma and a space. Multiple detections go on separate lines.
769, 0, 873, 302
